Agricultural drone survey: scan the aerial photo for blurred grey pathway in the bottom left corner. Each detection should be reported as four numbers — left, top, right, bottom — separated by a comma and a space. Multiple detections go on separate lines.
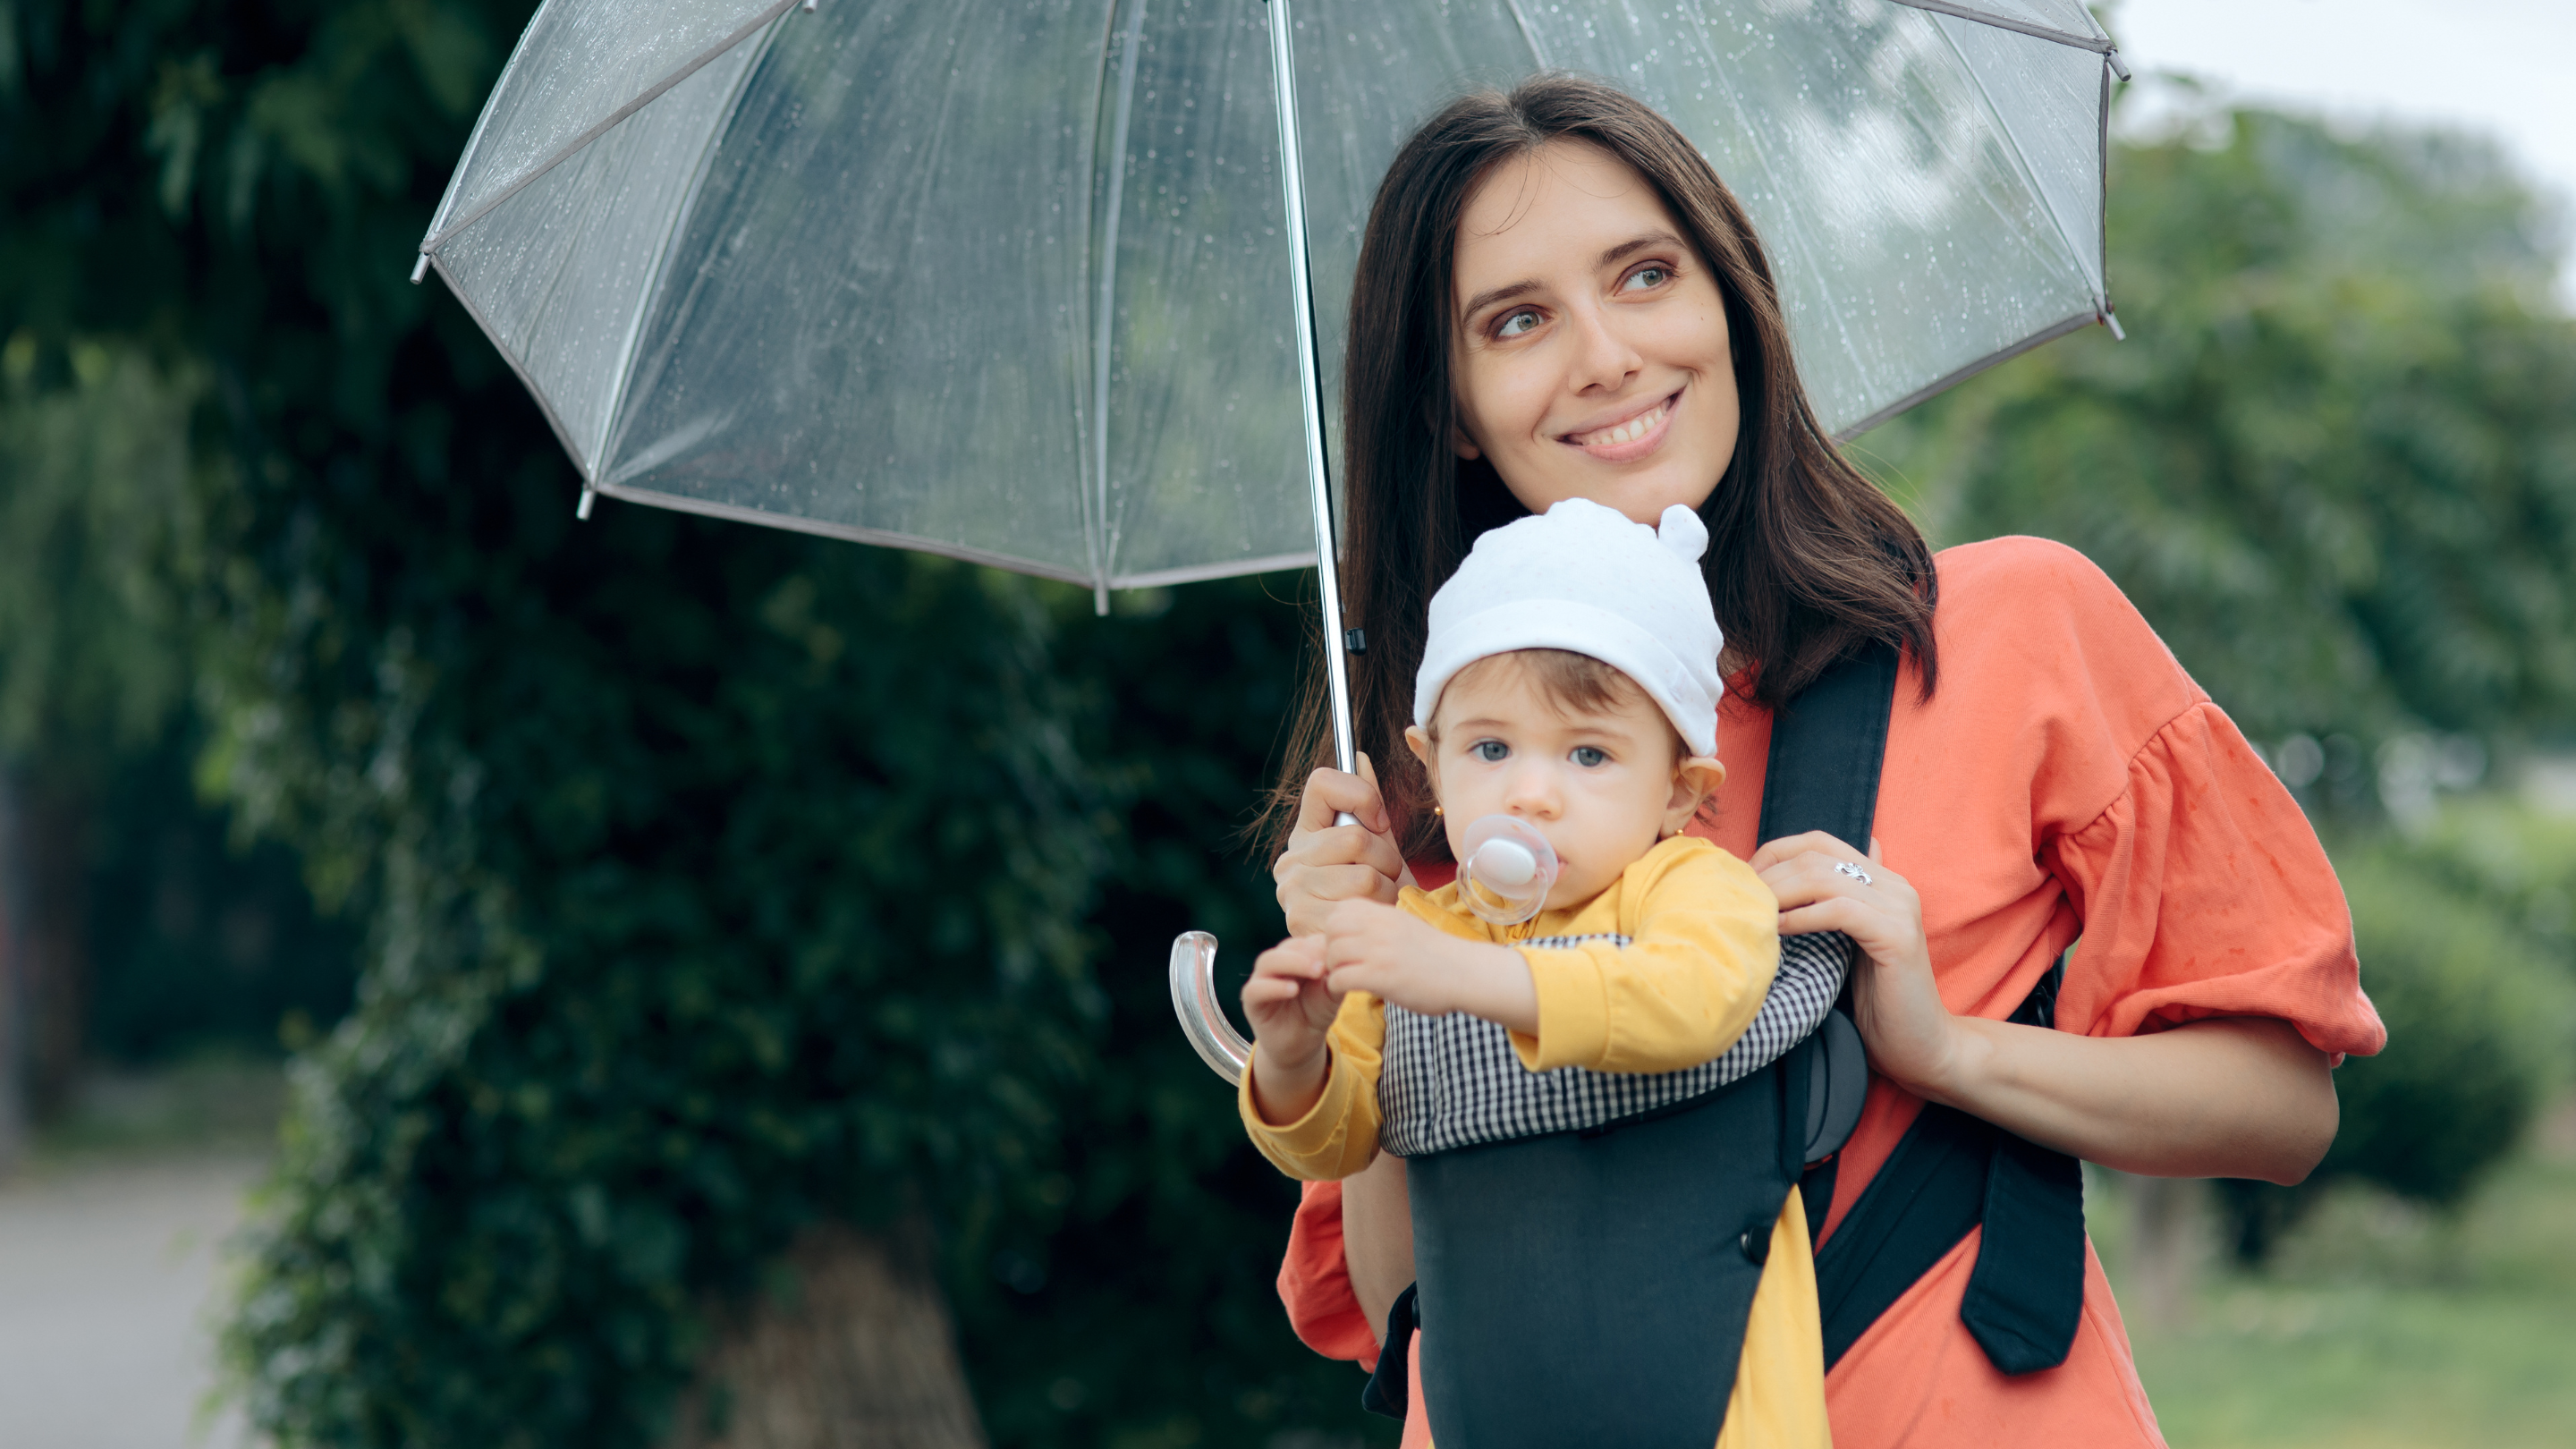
0, 1155, 260, 1449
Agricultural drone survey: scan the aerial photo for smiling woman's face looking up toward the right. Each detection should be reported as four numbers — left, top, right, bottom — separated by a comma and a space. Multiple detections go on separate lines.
1450, 142, 1739, 526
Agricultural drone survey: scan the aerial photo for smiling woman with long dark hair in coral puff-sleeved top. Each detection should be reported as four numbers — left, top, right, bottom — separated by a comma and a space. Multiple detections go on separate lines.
1273, 77, 2385, 1449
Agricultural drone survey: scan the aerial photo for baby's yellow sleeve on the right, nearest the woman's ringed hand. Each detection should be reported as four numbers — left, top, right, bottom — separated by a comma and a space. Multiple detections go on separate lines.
1513, 841, 1780, 1072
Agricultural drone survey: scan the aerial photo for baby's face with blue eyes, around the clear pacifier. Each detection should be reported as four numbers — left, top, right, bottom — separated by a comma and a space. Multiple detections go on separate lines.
1406, 660, 1724, 911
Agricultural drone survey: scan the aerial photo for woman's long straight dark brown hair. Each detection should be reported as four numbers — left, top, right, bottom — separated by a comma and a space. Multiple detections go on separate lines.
1262, 75, 1937, 859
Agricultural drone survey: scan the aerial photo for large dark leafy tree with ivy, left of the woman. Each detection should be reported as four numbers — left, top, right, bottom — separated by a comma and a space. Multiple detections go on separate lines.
0, 0, 1373, 1446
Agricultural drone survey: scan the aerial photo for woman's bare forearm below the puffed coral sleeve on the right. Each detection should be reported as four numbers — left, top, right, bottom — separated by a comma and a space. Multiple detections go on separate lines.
1903, 1016, 2336, 1183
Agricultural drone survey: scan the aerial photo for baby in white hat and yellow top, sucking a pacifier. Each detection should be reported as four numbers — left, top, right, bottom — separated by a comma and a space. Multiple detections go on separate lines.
1241, 500, 1842, 1444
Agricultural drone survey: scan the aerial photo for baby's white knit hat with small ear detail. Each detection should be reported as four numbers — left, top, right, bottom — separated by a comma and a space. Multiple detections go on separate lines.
1414, 497, 1726, 756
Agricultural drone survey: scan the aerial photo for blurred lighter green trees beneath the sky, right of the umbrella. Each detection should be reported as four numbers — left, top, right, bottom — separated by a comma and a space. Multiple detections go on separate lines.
1862, 111, 2576, 763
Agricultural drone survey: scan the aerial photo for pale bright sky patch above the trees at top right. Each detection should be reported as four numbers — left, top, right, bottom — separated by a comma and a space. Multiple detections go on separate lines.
2110, 0, 2576, 307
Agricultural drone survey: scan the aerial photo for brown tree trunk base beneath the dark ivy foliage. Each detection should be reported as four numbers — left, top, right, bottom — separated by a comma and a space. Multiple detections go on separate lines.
670, 1224, 984, 1449
